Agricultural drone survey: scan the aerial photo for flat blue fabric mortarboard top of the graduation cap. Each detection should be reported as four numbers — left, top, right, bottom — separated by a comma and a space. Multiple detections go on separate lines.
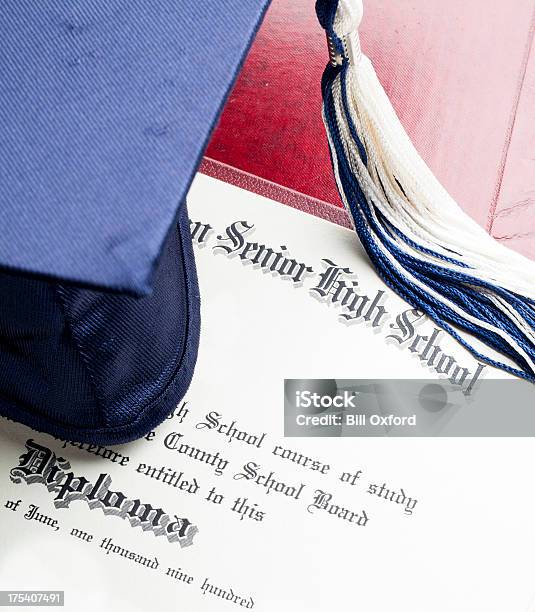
0, 0, 266, 294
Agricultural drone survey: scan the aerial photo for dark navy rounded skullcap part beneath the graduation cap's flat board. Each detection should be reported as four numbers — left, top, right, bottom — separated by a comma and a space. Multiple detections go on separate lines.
0, 206, 200, 444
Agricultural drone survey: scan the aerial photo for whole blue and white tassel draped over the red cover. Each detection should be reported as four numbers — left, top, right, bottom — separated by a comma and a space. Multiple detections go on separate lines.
316, 0, 535, 382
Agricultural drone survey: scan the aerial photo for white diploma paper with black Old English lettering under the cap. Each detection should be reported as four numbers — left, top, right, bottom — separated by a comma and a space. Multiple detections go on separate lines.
0, 175, 535, 612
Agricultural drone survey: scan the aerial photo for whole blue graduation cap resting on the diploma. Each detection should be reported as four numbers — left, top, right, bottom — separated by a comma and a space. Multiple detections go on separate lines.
0, 0, 267, 444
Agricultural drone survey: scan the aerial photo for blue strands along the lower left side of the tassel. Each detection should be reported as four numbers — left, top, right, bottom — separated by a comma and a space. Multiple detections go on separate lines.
324, 62, 535, 380
